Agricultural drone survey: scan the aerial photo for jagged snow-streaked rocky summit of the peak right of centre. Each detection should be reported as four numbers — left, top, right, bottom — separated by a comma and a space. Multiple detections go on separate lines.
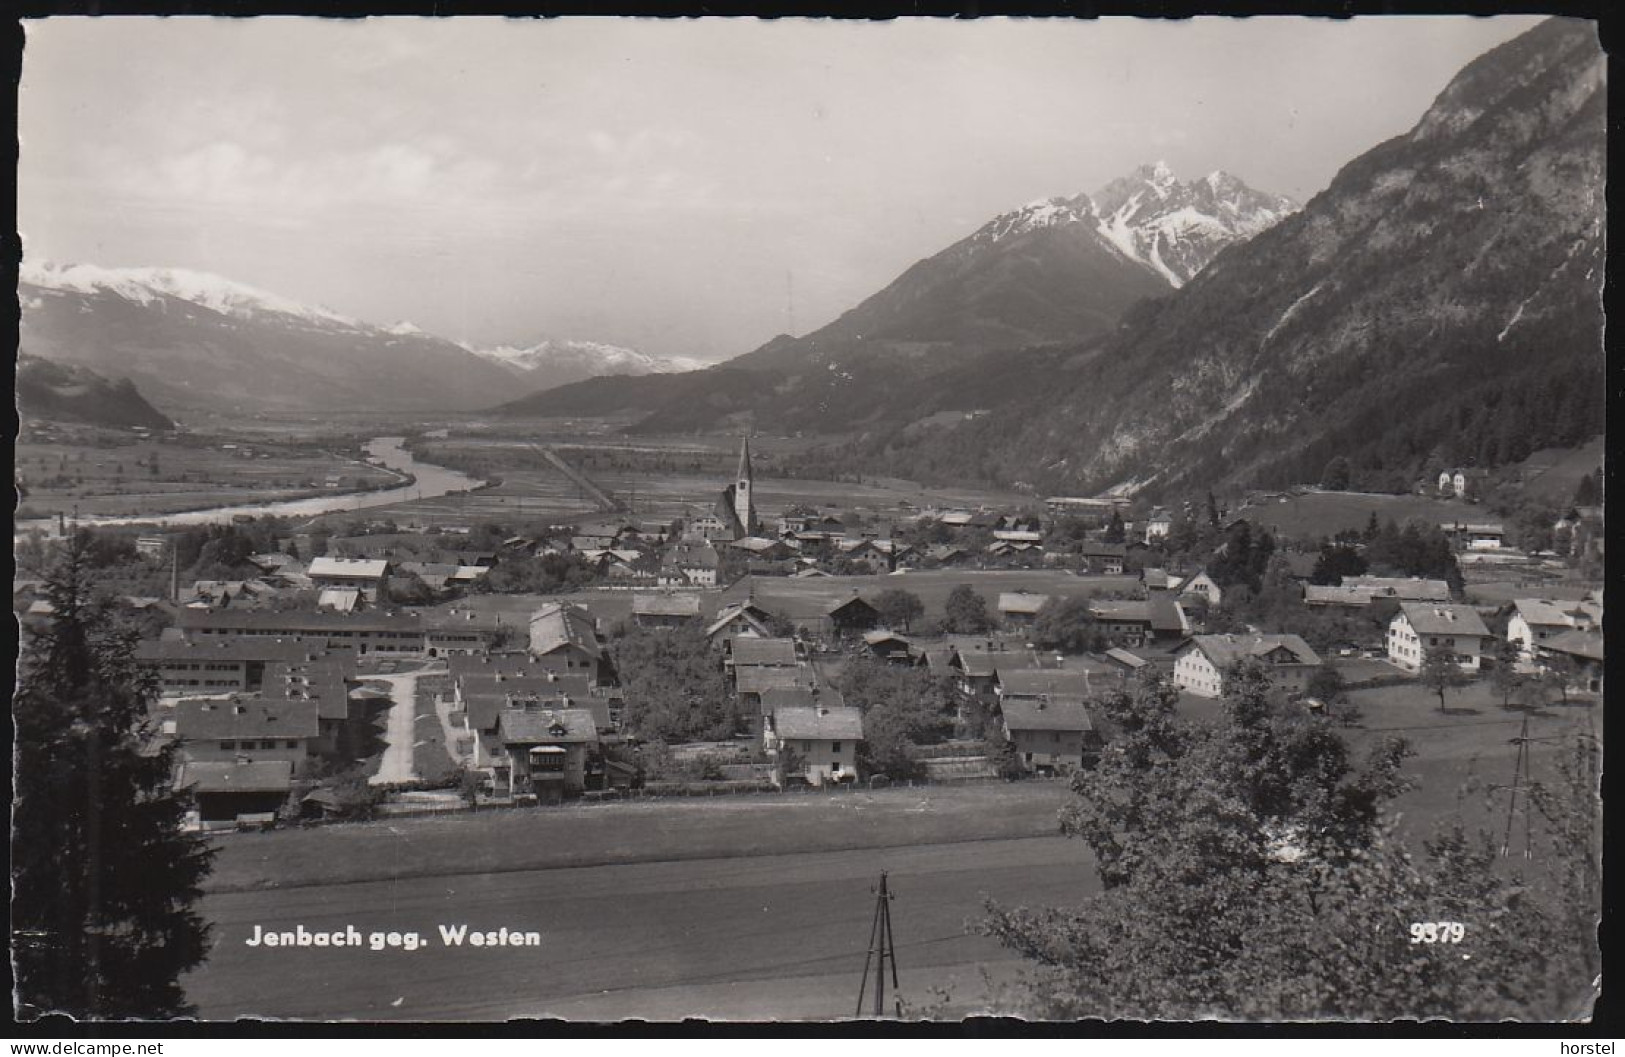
972, 161, 1298, 288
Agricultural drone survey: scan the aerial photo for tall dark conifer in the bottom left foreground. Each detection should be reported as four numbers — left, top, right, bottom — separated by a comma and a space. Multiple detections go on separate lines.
11, 532, 213, 1020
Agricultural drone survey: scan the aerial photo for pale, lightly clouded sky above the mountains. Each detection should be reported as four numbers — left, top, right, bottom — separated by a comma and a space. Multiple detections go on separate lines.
18, 18, 1537, 359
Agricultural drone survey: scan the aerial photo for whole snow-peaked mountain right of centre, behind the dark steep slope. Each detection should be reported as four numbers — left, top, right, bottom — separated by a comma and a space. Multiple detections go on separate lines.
501, 163, 1295, 422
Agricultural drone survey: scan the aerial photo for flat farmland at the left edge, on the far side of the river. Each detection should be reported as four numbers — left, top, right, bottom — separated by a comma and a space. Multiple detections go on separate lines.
13, 437, 398, 519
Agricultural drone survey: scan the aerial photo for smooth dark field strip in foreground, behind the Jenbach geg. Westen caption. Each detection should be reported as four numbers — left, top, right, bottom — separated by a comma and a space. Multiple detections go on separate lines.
187, 837, 1094, 1020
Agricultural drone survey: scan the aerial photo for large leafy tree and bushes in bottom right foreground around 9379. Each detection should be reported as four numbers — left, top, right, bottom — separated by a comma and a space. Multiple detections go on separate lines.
985, 665, 1601, 1020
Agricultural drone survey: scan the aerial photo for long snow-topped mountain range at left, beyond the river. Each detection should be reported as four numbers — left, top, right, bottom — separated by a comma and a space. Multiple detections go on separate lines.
18, 262, 692, 411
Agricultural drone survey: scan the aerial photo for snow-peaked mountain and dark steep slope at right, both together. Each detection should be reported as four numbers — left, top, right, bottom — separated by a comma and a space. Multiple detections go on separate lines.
507, 18, 1607, 494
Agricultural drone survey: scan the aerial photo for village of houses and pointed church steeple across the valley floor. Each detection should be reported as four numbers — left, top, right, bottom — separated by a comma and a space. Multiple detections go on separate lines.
15, 439, 1602, 833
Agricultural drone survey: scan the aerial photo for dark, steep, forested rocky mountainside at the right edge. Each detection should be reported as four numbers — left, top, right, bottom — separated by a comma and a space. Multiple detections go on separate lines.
853, 20, 1606, 493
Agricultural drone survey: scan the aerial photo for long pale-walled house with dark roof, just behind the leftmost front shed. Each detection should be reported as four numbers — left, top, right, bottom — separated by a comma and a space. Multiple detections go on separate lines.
174, 694, 322, 768
